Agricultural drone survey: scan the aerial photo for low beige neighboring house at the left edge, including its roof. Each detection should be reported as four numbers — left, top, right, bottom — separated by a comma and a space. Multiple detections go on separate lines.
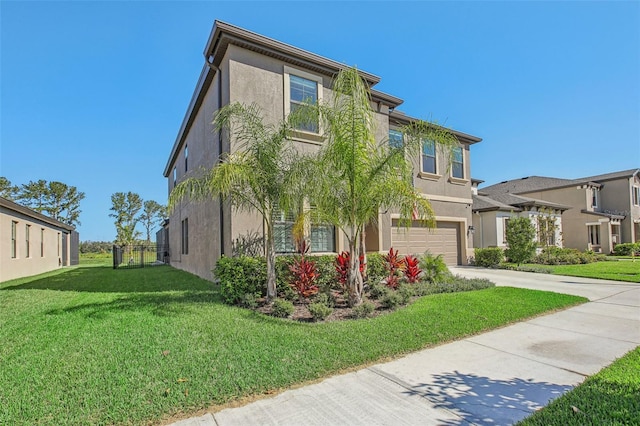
0, 197, 78, 281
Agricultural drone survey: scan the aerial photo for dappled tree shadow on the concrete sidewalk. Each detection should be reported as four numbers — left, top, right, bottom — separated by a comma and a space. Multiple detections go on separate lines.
406, 371, 572, 426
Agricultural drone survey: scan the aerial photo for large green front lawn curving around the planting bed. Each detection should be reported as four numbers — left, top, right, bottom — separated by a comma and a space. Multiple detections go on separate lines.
0, 266, 586, 425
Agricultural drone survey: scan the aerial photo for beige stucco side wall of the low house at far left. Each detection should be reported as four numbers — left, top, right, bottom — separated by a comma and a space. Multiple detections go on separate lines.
0, 207, 71, 282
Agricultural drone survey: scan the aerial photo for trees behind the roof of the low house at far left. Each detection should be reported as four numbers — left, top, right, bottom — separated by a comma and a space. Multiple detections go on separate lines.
0, 176, 85, 226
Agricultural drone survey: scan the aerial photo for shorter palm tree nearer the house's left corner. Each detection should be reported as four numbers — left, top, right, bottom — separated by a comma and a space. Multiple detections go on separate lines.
169, 103, 301, 299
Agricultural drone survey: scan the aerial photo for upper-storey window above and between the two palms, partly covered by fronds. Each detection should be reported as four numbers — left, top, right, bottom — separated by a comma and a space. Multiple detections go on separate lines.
284, 66, 322, 139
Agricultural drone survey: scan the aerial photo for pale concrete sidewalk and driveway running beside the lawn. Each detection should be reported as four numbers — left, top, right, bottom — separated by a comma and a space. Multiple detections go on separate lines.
174, 268, 640, 426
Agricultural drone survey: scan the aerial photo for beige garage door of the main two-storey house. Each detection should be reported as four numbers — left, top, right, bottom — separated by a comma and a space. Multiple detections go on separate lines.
391, 219, 460, 265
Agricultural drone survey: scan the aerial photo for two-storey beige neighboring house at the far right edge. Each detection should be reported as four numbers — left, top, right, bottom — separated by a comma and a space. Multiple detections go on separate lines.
479, 169, 640, 254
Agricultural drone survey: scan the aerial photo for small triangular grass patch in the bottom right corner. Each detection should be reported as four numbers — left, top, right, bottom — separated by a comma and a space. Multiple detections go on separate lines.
518, 347, 640, 426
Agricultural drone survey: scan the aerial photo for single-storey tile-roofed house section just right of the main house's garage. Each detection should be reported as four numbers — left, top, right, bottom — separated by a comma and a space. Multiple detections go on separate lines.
473, 180, 569, 248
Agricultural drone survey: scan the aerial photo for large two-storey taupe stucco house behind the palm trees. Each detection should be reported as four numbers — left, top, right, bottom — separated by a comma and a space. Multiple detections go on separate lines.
164, 21, 481, 278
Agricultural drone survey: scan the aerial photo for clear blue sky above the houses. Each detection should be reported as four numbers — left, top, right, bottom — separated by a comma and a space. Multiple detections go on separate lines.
0, 1, 640, 241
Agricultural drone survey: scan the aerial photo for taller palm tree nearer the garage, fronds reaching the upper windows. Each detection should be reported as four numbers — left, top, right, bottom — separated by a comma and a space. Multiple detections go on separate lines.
308, 68, 458, 305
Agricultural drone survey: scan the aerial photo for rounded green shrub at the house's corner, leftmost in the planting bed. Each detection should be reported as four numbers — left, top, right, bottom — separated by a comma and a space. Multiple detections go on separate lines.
213, 256, 267, 304
